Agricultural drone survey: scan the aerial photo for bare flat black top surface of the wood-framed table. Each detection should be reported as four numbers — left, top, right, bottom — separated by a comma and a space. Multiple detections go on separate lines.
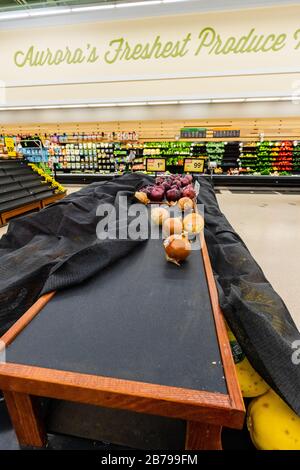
7, 222, 227, 393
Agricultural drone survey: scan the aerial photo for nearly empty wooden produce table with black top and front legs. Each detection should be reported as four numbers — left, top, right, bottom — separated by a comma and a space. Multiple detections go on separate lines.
0, 233, 245, 450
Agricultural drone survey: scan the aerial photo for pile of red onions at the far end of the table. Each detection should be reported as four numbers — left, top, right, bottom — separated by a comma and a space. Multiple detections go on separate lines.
140, 175, 196, 202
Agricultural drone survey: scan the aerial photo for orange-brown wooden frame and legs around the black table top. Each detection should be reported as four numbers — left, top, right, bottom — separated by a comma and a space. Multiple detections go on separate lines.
0, 237, 245, 450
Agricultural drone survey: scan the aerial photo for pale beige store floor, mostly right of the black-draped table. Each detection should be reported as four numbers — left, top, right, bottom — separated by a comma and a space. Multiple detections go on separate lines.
0, 186, 300, 329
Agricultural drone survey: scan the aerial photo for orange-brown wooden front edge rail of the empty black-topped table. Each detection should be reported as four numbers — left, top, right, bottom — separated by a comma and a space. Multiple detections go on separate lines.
0, 363, 241, 428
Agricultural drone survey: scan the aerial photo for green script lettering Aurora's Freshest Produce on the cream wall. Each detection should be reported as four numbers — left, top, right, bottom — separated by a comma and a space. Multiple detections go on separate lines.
14, 26, 300, 67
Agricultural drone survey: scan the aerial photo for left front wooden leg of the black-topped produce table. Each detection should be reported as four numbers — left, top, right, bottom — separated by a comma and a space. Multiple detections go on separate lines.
3, 391, 47, 447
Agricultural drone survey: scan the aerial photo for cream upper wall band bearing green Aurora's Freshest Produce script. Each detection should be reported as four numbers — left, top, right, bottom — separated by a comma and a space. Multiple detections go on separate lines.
0, 2, 300, 106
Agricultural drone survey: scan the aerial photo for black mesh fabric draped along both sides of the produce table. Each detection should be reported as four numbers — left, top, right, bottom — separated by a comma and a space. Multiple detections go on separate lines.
0, 174, 300, 414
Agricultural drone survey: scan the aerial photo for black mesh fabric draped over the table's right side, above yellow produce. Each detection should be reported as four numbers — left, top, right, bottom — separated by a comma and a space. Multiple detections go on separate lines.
198, 177, 300, 415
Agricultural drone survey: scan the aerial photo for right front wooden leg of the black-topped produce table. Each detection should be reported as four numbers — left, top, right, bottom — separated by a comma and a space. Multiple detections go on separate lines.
185, 421, 222, 450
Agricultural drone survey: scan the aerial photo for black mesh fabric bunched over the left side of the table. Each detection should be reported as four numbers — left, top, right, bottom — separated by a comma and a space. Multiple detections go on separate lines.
0, 174, 148, 335
